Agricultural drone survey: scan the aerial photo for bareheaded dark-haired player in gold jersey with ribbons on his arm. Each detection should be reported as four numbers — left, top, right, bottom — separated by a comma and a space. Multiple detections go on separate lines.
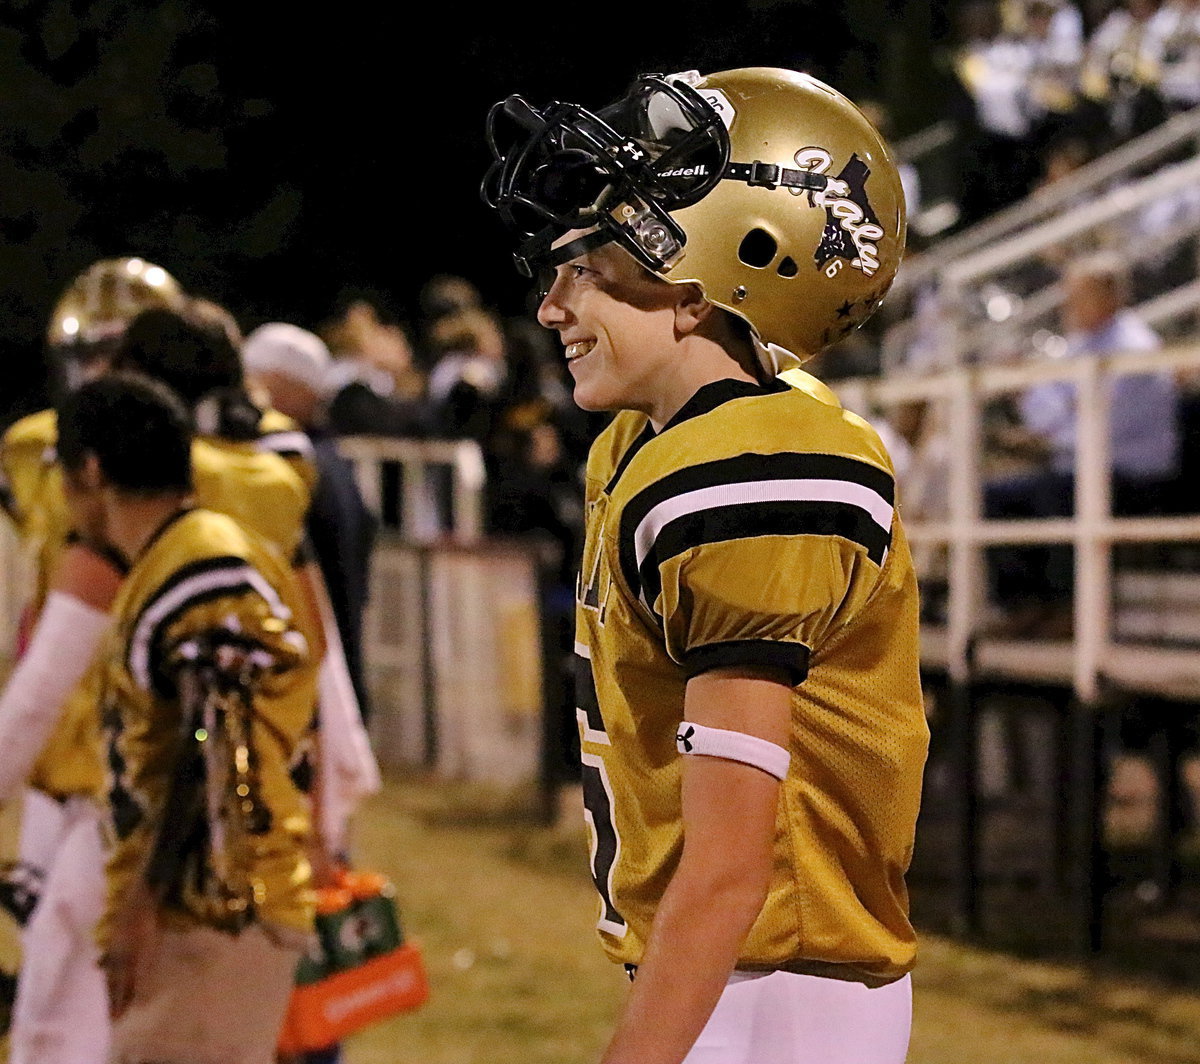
59, 373, 317, 1064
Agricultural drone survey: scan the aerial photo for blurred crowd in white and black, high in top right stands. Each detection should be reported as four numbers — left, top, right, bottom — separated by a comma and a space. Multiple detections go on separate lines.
946, 0, 1200, 227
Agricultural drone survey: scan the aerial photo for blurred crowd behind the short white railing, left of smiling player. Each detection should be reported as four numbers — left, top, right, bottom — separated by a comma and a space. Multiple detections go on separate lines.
244, 276, 596, 573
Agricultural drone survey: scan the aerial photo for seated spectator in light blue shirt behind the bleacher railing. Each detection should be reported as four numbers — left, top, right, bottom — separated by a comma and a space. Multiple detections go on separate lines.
984, 254, 1180, 636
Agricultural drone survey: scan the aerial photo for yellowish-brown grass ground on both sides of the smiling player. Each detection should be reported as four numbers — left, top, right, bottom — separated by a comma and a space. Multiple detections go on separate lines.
7, 779, 1200, 1064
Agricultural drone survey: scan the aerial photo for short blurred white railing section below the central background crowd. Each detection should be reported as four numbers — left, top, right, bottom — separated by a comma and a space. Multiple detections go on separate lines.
337, 437, 486, 542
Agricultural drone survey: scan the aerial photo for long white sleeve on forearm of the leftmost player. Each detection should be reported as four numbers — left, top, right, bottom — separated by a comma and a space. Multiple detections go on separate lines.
0, 591, 109, 801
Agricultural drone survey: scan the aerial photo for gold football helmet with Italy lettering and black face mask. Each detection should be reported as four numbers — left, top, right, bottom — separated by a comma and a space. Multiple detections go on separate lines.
484, 67, 905, 368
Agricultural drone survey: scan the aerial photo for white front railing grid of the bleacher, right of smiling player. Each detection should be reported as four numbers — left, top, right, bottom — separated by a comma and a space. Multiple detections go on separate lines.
836, 344, 1200, 701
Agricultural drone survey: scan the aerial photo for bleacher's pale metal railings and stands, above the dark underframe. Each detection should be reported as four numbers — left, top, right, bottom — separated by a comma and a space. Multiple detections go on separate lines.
836, 112, 1200, 699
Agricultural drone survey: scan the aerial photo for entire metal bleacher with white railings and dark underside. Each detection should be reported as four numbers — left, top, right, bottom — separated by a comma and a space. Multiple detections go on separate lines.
835, 109, 1200, 964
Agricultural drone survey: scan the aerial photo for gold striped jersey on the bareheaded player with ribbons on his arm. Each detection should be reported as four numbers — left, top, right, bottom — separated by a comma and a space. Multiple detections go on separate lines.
100, 510, 317, 942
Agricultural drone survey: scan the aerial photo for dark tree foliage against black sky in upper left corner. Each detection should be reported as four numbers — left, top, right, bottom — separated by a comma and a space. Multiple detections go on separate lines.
0, 0, 292, 429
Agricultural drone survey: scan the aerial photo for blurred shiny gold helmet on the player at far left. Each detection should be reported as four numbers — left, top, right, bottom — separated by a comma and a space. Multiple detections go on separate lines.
46, 258, 185, 354
